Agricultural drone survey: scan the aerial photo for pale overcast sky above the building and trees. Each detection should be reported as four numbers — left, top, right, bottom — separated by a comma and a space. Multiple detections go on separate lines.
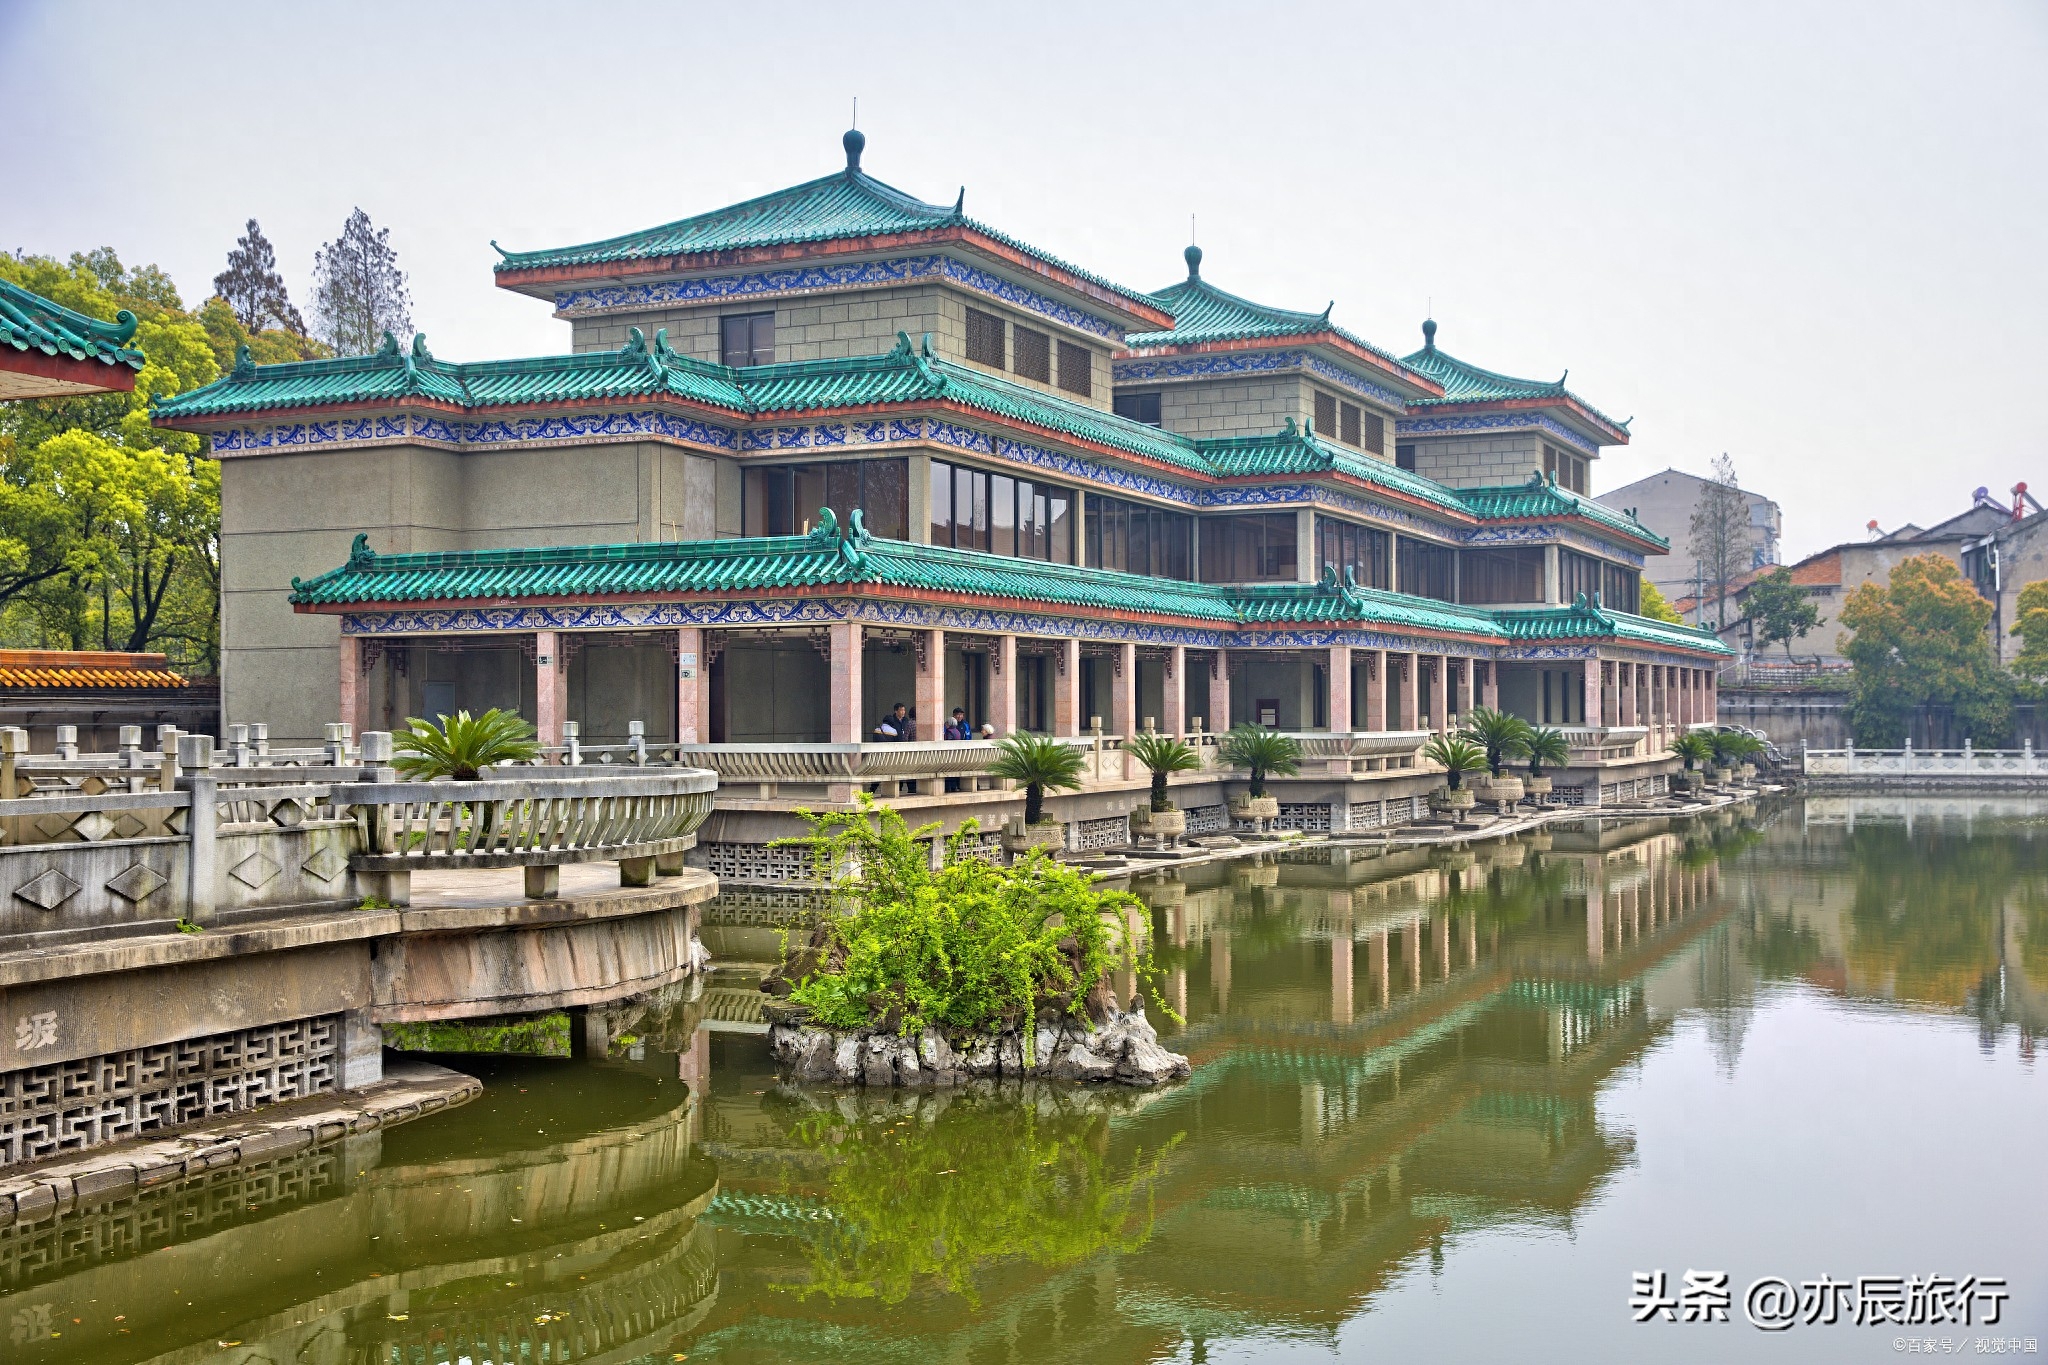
0, 0, 2048, 557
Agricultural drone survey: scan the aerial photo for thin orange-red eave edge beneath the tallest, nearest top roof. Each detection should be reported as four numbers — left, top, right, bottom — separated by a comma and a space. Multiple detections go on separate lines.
496, 221, 1174, 332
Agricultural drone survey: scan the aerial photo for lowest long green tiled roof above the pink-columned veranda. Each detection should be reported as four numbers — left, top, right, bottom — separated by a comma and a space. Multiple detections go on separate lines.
291, 520, 1726, 653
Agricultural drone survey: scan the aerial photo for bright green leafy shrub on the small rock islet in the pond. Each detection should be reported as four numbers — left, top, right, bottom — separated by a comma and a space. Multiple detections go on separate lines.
782, 796, 1151, 1046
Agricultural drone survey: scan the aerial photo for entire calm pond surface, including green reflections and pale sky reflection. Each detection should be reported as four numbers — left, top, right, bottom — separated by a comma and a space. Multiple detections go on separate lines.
0, 798, 2048, 1365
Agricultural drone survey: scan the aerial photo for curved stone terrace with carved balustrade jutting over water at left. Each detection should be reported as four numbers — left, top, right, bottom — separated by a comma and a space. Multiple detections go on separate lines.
0, 726, 717, 1186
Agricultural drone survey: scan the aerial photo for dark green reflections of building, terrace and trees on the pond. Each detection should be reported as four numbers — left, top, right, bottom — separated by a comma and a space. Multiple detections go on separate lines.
0, 800, 2048, 1365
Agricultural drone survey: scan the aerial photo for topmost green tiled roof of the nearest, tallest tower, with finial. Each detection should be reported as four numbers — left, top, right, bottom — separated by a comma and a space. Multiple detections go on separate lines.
496, 135, 1151, 315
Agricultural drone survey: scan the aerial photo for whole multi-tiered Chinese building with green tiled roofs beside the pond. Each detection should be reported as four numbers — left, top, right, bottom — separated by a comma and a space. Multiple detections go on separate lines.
158, 133, 1726, 855
